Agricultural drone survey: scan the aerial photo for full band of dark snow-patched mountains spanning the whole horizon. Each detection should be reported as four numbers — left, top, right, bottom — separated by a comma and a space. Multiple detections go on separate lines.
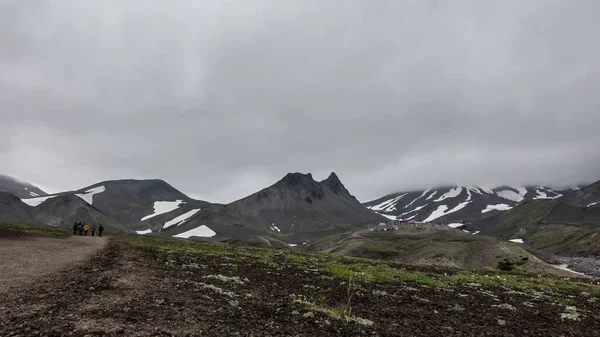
0, 173, 600, 250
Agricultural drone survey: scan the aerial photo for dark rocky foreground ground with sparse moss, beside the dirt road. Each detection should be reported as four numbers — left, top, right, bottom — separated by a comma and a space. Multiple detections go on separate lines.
0, 227, 600, 336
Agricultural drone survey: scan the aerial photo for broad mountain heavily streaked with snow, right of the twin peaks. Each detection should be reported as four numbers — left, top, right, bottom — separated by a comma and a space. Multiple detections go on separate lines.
364, 186, 562, 224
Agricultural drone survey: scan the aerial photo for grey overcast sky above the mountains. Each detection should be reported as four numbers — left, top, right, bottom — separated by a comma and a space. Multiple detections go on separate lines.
0, 0, 600, 202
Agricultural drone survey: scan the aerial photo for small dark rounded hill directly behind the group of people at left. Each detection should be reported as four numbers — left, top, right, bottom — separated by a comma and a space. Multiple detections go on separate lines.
33, 194, 126, 231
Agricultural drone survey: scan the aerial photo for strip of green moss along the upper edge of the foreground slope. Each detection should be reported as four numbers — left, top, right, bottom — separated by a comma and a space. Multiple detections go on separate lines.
118, 235, 600, 294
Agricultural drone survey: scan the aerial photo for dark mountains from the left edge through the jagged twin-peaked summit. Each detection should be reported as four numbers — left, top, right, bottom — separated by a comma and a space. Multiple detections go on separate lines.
0, 173, 383, 237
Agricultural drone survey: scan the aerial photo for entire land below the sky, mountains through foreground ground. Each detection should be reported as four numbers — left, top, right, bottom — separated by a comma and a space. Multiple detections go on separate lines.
0, 173, 600, 336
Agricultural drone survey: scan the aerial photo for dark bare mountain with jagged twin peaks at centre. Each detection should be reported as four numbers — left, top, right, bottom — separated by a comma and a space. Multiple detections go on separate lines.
169, 173, 382, 236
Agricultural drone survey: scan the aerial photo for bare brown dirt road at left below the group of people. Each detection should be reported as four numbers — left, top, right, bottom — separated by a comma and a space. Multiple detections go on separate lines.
0, 236, 107, 293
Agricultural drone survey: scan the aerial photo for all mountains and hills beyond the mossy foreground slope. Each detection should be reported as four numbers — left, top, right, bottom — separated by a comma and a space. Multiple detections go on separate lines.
0, 173, 600, 276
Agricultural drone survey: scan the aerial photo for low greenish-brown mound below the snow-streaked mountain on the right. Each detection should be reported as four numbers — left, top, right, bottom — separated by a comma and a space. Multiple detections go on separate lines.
306, 227, 568, 275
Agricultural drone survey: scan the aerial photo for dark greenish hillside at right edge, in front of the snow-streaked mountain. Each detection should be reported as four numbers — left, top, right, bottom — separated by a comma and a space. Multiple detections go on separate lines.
465, 200, 600, 256
